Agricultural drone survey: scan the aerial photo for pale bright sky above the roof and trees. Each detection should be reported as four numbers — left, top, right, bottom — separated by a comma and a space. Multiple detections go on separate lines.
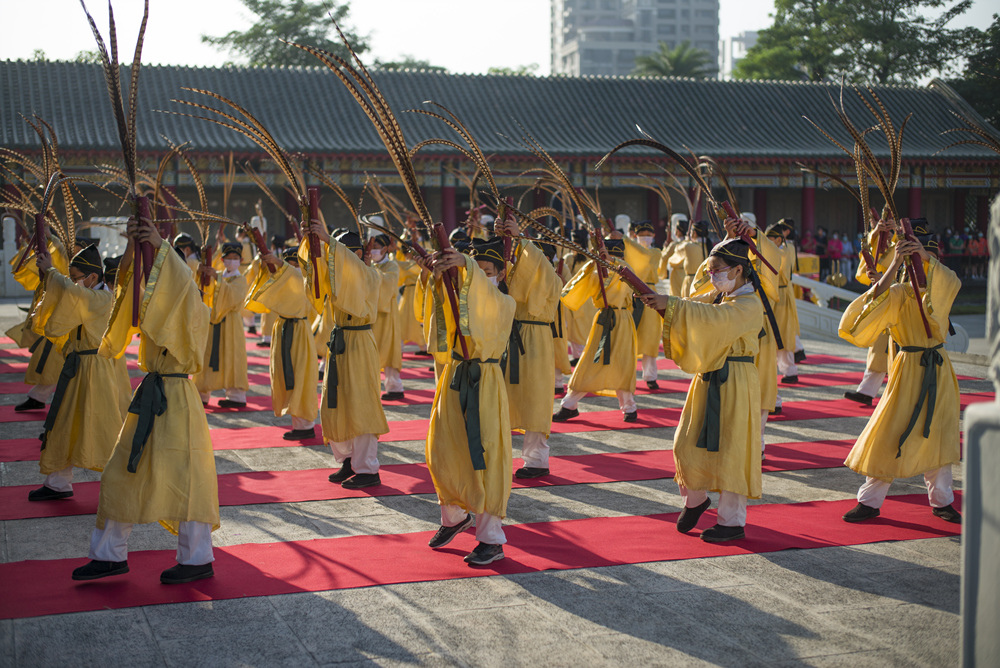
0, 0, 1000, 74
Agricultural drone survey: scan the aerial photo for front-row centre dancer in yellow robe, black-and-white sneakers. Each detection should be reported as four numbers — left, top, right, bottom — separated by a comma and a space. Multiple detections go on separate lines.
427, 249, 516, 566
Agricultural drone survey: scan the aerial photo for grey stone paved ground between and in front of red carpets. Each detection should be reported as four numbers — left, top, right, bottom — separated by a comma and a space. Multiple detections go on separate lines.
0, 304, 992, 667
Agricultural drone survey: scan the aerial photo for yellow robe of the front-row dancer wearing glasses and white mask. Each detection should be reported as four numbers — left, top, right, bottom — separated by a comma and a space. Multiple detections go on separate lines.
663, 292, 763, 499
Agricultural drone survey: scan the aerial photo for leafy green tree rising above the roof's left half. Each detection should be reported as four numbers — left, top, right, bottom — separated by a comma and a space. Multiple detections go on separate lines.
201, 0, 368, 67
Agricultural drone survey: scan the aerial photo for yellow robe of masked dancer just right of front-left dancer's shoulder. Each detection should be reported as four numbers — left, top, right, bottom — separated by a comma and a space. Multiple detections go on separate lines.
194, 274, 250, 393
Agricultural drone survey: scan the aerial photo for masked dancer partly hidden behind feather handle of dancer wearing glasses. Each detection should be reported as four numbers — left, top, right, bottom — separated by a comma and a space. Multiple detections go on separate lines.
625, 220, 663, 390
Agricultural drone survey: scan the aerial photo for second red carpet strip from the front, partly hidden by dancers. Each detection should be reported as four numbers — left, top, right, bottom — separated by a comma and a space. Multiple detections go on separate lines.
0, 441, 853, 520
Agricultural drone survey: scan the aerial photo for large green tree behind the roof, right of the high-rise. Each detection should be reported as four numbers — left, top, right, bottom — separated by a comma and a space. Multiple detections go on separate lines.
735, 0, 978, 84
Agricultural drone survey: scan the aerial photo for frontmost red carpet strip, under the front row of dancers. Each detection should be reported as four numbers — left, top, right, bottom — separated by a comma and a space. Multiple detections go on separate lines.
0, 494, 961, 619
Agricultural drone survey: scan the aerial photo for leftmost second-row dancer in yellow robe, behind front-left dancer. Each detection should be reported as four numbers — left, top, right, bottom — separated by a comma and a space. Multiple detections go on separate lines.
28, 245, 132, 501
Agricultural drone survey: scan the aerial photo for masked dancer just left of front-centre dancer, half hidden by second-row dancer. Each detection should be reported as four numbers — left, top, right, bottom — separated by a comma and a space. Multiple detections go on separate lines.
371, 234, 403, 401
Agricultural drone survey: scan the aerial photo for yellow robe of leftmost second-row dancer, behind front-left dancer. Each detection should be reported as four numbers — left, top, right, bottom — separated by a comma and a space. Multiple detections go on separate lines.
31, 269, 132, 475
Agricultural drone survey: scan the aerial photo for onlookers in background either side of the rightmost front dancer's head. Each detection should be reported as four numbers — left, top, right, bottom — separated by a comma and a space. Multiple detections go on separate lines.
801, 227, 989, 281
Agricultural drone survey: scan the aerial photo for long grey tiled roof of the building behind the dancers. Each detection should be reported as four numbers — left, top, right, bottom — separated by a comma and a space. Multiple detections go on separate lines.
0, 61, 997, 161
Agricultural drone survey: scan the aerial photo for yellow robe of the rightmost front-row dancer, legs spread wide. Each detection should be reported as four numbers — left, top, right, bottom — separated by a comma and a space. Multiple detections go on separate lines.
840, 258, 962, 481
